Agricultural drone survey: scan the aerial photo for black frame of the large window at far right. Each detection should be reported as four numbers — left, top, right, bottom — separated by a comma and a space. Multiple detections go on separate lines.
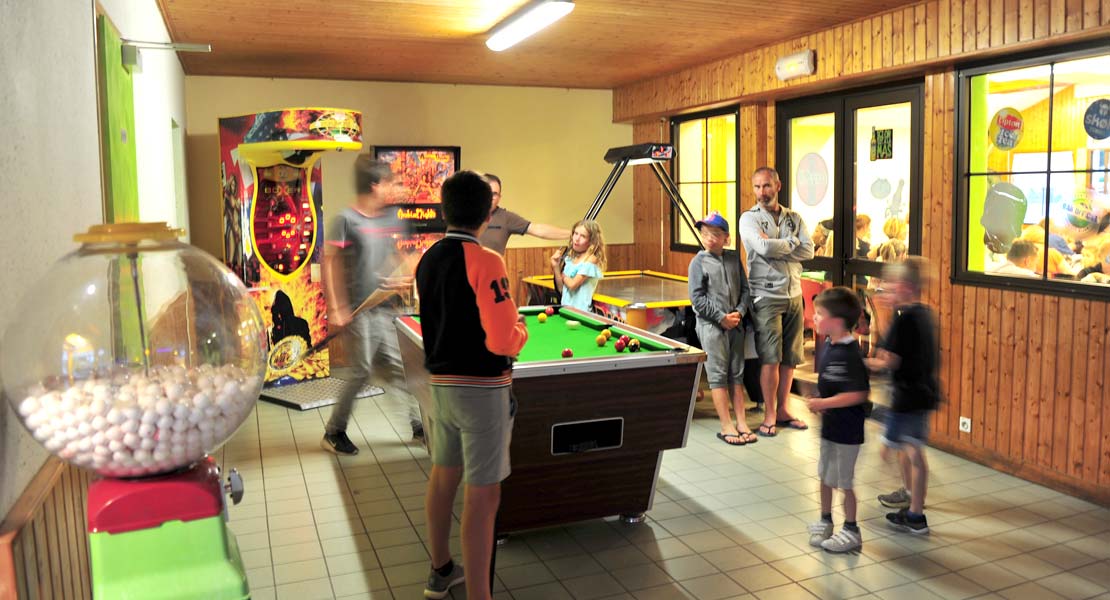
950, 42, 1110, 302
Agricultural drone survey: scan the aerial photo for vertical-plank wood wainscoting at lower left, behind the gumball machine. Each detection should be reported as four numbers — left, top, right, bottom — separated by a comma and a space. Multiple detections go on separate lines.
0, 457, 92, 600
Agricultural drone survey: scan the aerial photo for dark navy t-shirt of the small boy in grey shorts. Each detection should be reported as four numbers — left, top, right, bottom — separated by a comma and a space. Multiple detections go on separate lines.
817, 339, 871, 444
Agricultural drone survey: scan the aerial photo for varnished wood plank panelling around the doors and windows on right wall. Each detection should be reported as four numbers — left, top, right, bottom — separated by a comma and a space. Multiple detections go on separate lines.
626, 0, 1110, 506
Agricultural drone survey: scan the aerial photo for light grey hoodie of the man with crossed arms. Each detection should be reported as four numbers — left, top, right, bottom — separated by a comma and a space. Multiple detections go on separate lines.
738, 204, 814, 298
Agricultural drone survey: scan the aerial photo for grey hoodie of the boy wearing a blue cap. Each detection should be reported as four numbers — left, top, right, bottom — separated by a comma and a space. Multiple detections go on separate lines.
688, 250, 751, 327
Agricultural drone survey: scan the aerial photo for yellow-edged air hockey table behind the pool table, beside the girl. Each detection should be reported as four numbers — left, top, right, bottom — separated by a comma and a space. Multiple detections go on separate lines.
523, 271, 690, 333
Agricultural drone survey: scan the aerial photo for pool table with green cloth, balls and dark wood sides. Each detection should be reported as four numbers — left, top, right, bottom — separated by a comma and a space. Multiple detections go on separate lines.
395, 306, 705, 535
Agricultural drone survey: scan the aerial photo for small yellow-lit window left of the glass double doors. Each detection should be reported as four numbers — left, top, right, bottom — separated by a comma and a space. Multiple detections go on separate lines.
670, 108, 739, 250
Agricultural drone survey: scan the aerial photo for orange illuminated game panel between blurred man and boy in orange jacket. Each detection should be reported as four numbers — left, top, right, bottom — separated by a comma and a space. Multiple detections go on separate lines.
374, 146, 462, 257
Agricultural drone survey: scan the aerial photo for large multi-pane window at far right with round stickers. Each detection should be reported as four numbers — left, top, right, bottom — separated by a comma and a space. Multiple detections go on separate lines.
956, 45, 1110, 298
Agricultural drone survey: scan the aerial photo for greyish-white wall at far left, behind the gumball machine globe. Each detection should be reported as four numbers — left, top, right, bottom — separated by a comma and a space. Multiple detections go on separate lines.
0, 0, 103, 518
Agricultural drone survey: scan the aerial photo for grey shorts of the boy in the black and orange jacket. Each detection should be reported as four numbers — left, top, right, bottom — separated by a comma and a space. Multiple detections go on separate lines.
430, 385, 516, 486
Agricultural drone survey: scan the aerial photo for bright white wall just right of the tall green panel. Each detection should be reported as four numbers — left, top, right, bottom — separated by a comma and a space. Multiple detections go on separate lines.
100, 0, 189, 240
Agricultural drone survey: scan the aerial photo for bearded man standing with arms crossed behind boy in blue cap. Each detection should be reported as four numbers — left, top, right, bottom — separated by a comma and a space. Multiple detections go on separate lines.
739, 166, 814, 437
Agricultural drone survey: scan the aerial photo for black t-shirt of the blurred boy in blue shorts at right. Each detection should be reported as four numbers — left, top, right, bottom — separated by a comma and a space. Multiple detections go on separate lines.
882, 304, 940, 413
